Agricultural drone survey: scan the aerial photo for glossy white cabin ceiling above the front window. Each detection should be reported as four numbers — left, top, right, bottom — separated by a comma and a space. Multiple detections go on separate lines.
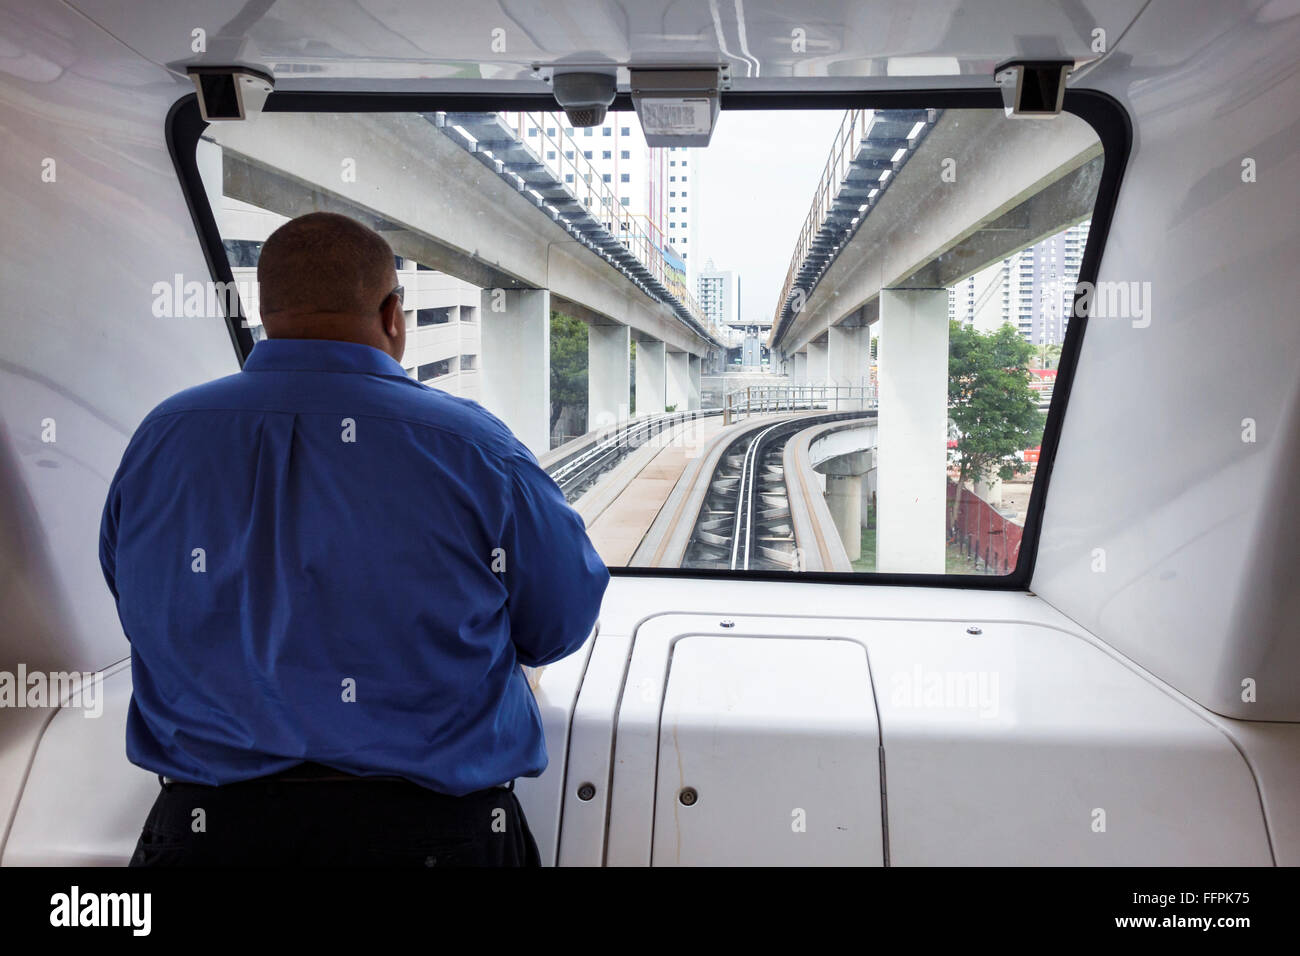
63, 0, 1145, 90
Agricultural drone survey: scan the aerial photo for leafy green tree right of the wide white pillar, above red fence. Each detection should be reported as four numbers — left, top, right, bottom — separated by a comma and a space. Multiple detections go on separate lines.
948, 321, 1045, 528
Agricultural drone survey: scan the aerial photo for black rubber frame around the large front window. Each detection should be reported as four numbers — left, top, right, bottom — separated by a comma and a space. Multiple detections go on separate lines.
164, 87, 1132, 591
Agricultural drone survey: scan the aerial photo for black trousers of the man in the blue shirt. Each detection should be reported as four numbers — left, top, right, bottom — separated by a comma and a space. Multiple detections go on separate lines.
130, 778, 541, 868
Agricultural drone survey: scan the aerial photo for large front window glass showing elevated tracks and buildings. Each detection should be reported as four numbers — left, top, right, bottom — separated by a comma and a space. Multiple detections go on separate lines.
198, 105, 1109, 581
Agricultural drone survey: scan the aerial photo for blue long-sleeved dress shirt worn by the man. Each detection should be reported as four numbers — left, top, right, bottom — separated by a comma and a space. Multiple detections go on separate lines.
100, 339, 610, 795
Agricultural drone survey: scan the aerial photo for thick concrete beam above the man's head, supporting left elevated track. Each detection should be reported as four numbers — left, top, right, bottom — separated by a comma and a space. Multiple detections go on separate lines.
208, 113, 709, 355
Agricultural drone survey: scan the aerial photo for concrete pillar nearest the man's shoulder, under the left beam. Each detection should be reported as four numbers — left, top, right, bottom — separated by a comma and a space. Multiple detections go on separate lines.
478, 289, 551, 455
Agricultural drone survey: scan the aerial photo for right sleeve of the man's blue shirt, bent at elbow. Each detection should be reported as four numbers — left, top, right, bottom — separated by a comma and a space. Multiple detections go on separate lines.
502, 455, 610, 667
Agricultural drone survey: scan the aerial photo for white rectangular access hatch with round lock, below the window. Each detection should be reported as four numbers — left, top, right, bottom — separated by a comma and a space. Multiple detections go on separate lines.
651, 637, 884, 866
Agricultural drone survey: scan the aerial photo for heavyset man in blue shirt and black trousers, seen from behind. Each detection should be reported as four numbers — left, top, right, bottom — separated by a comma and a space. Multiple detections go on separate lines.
100, 213, 608, 865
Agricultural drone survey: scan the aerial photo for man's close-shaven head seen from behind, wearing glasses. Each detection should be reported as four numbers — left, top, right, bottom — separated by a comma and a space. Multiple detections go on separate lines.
257, 212, 406, 362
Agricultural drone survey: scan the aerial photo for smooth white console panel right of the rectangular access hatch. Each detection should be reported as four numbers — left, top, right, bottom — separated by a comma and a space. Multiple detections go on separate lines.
868, 622, 1271, 866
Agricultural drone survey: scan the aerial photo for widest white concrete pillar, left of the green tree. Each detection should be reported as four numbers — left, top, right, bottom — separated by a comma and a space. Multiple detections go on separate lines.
876, 289, 948, 574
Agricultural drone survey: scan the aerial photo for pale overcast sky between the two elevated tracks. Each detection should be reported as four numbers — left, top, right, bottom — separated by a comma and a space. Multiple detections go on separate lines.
690, 109, 844, 321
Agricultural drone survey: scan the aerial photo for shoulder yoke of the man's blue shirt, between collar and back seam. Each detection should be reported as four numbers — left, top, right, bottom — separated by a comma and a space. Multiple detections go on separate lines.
139, 372, 530, 459
